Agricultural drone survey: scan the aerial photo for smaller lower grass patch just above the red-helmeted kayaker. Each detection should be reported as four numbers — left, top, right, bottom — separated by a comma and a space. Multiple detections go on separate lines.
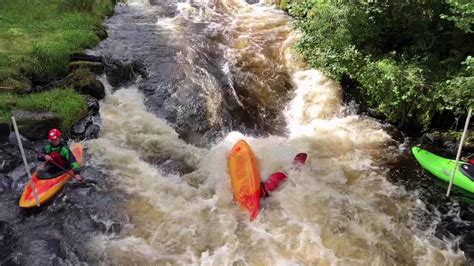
0, 89, 87, 131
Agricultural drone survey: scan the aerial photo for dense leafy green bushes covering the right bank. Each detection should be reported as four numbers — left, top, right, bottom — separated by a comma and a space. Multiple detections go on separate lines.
280, 0, 474, 128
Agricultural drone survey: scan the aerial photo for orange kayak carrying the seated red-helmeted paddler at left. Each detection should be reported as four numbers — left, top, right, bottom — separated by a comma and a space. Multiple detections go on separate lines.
19, 143, 84, 208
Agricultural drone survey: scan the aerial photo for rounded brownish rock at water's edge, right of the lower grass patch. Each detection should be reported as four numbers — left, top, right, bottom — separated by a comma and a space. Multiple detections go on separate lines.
65, 68, 105, 100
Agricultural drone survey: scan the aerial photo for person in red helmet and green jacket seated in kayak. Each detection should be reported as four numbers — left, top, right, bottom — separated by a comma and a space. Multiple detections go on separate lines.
38, 128, 82, 181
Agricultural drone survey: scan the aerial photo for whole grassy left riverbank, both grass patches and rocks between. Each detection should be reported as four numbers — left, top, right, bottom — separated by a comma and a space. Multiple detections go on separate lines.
0, 0, 117, 136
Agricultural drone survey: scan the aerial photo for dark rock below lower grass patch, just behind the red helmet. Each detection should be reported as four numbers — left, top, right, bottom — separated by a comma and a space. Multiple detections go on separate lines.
12, 109, 61, 139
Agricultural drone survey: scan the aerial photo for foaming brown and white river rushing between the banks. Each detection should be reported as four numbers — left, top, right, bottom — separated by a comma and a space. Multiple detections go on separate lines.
0, 0, 474, 265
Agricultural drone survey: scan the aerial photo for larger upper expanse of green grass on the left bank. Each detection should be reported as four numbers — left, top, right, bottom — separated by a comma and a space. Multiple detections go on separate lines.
0, 0, 115, 87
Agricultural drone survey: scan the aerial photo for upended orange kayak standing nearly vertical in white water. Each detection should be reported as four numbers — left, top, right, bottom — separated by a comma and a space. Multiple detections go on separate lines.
228, 140, 260, 220
